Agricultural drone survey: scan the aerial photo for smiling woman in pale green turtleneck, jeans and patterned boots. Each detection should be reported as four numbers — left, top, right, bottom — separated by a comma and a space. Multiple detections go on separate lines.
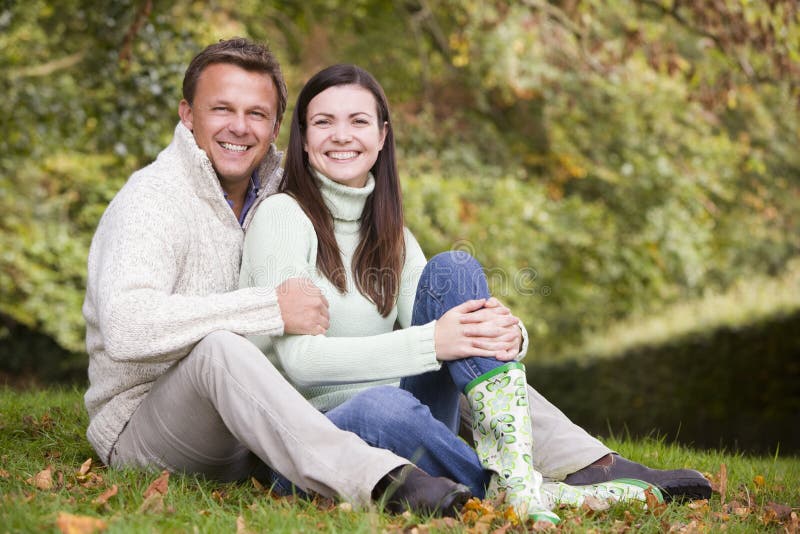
240, 65, 658, 523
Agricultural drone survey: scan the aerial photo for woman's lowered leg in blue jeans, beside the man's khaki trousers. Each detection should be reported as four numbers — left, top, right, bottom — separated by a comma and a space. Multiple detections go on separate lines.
325, 386, 490, 498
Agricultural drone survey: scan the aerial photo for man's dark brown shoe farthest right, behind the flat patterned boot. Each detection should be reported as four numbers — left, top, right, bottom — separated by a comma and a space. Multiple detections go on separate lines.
564, 454, 711, 502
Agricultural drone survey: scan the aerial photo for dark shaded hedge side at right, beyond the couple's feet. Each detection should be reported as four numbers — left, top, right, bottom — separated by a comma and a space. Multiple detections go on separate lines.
528, 311, 800, 454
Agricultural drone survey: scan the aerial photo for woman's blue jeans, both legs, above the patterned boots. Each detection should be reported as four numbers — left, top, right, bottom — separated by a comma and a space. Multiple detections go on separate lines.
278, 251, 503, 498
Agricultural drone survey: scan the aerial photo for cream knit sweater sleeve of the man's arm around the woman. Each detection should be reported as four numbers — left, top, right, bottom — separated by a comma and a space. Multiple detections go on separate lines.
84, 183, 283, 362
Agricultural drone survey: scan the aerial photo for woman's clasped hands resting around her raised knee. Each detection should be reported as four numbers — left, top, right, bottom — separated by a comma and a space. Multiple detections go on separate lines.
434, 298, 522, 361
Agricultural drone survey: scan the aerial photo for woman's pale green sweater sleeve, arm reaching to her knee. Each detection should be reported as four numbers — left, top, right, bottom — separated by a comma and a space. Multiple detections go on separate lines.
240, 195, 441, 386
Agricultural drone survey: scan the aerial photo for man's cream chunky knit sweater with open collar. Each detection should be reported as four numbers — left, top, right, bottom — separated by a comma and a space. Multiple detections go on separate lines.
83, 123, 283, 462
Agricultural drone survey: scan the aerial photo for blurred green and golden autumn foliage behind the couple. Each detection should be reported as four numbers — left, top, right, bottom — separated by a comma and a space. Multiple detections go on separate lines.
0, 0, 800, 450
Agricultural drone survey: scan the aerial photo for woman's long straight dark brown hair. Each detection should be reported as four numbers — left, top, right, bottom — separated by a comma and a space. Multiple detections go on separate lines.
280, 65, 405, 317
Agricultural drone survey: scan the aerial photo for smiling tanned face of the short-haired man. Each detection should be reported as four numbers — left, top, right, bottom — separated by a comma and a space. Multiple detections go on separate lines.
179, 63, 280, 192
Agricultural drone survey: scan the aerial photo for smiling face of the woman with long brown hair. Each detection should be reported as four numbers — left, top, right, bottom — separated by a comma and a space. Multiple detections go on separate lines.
303, 85, 386, 187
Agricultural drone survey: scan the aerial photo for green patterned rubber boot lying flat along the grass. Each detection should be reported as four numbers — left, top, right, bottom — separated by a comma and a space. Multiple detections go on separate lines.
542, 478, 664, 508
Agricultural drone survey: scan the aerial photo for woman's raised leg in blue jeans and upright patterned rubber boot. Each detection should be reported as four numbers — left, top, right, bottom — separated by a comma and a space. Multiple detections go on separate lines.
401, 251, 559, 523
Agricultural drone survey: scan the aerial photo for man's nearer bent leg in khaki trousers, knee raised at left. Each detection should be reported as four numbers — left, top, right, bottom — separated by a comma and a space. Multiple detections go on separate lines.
111, 332, 409, 504
